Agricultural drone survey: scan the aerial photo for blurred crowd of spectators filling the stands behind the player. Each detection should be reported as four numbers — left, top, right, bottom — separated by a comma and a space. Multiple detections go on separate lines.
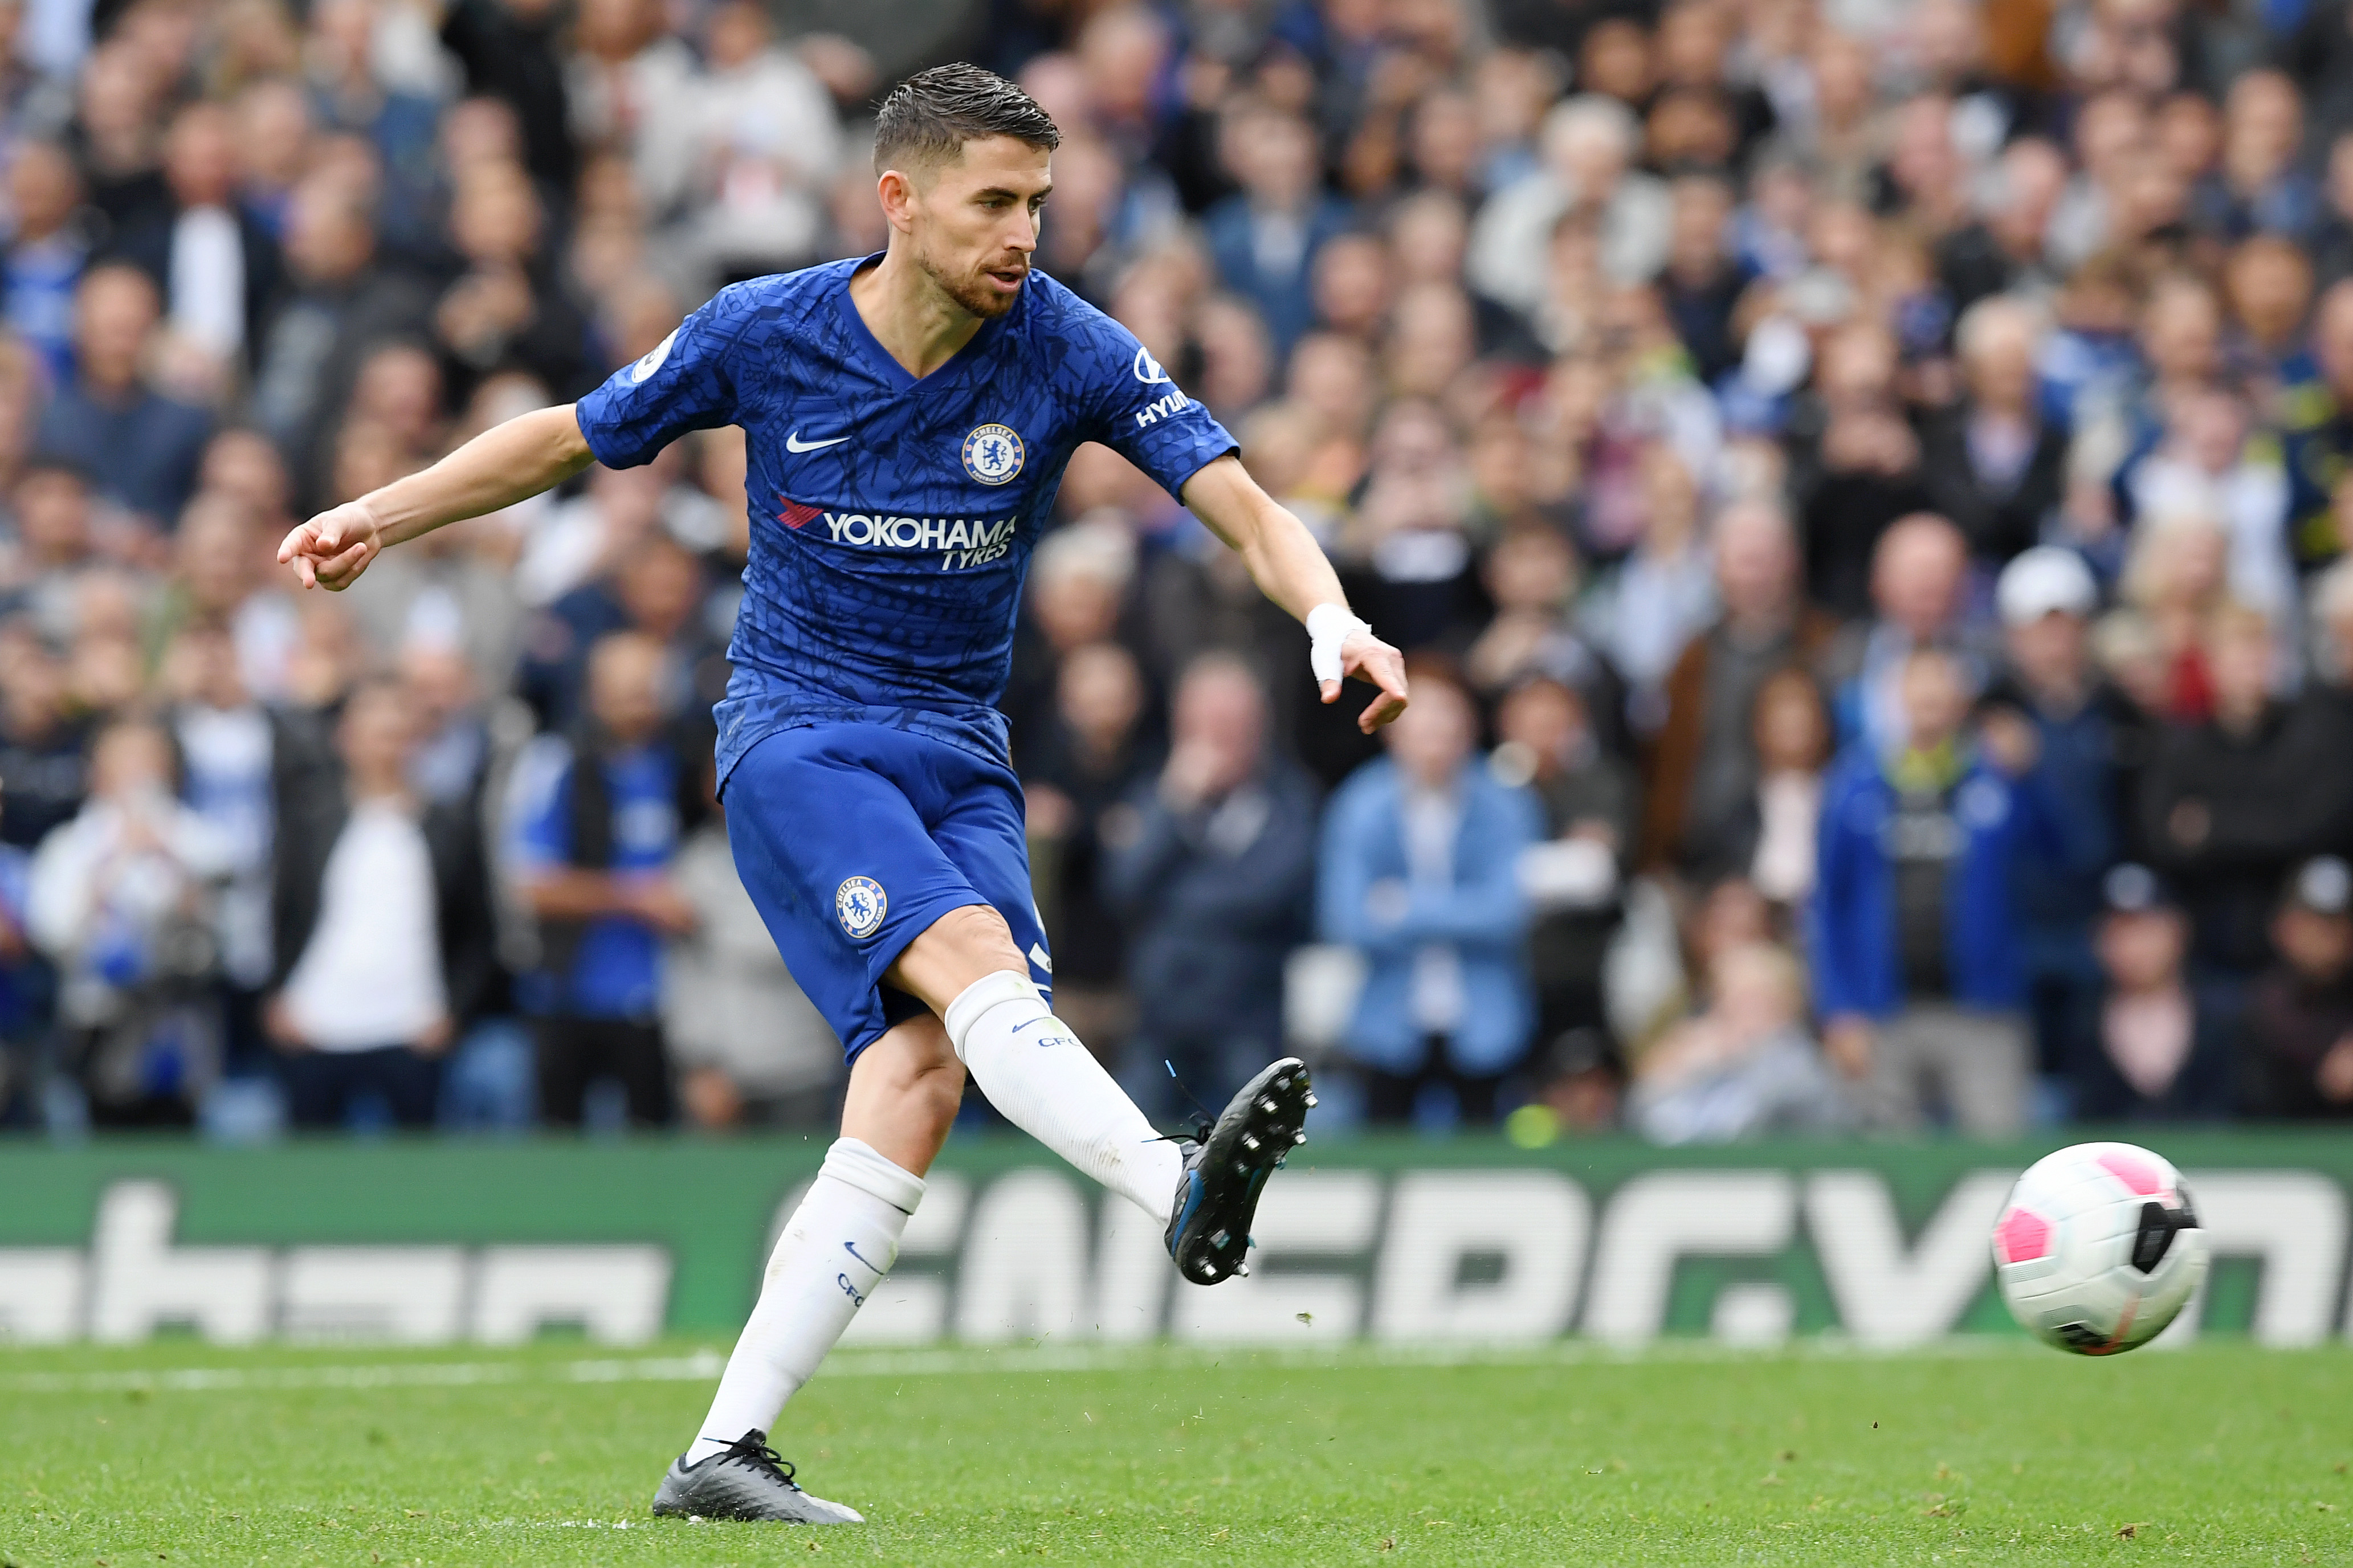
0, 0, 2353, 1142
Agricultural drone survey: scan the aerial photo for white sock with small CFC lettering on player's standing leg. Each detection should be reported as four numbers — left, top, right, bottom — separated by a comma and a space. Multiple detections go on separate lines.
687, 1138, 923, 1464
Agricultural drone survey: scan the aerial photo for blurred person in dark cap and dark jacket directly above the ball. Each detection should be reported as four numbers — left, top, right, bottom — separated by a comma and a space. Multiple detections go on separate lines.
2073, 863, 2238, 1121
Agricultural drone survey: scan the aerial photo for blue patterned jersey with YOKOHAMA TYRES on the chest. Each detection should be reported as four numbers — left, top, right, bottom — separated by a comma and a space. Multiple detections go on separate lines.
579, 256, 1235, 781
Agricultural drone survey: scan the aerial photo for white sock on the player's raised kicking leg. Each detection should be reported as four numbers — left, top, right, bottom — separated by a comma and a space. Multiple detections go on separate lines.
946, 969, 1184, 1225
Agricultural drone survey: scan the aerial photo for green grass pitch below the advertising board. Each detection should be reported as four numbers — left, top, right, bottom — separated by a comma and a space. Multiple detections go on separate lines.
0, 1342, 2353, 1568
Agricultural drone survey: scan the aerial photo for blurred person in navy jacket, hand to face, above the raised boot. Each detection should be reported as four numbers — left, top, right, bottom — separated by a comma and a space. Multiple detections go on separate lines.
1101, 654, 1315, 1102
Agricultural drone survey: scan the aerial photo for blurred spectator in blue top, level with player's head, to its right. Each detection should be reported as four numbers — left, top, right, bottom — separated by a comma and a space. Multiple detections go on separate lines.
1209, 108, 1348, 362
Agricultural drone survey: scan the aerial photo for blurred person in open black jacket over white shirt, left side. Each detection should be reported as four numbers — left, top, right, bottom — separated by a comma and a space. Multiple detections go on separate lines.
263, 682, 496, 1128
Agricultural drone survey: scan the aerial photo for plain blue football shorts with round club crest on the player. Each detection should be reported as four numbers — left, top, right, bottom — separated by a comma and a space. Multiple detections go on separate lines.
723, 724, 1054, 1060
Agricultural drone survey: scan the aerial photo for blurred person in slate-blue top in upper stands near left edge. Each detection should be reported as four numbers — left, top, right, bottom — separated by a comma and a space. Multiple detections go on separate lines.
35, 263, 212, 529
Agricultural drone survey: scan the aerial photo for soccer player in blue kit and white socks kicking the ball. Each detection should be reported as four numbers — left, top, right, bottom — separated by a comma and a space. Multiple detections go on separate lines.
278, 66, 1405, 1524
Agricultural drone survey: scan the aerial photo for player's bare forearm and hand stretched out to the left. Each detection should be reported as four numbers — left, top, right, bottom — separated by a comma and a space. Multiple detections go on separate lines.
278, 405, 596, 593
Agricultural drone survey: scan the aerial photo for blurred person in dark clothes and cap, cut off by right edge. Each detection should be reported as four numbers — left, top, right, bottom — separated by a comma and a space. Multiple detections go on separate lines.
2240, 856, 2353, 1121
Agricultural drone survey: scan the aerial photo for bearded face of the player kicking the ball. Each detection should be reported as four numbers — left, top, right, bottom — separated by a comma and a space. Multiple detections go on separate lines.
908, 136, 1054, 317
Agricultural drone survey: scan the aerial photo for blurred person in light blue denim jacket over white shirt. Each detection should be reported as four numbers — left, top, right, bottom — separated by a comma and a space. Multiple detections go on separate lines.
1315, 663, 1544, 1124
